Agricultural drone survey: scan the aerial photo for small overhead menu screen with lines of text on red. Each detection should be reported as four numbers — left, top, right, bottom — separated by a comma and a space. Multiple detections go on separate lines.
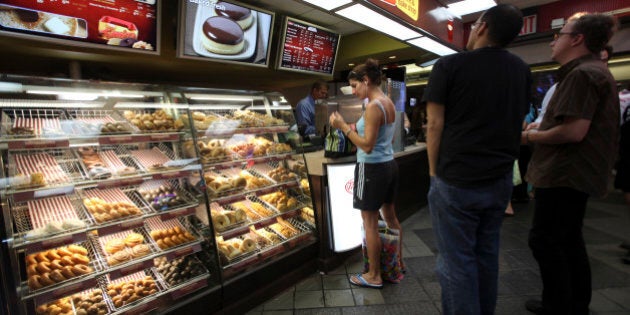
278, 17, 341, 75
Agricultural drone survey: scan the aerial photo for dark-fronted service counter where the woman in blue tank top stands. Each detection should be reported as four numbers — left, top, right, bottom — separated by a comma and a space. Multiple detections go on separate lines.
304, 143, 429, 272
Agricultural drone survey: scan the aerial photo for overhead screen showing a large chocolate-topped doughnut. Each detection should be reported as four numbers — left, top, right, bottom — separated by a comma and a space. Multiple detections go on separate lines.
178, 0, 274, 67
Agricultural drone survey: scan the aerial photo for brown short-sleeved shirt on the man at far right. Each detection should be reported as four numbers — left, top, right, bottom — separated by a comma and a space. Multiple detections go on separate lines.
526, 55, 619, 196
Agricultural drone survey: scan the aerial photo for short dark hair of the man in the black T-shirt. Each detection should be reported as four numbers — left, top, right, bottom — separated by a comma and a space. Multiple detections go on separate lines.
480, 3, 523, 47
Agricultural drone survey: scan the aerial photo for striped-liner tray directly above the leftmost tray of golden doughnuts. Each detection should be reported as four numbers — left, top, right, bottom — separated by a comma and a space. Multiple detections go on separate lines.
8, 194, 93, 251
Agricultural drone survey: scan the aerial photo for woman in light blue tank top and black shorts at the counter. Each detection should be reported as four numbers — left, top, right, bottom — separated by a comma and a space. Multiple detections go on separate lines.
330, 59, 404, 288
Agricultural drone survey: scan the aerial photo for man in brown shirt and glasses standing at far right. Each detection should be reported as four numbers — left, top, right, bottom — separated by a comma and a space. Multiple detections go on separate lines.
521, 13, 619, 314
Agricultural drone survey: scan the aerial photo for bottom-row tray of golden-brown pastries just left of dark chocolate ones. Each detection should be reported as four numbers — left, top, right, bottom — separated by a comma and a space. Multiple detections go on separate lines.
99, 268, 167, 314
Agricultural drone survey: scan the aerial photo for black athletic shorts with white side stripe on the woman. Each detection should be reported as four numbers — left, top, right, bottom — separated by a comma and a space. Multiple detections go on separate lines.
352, 160, 398, 211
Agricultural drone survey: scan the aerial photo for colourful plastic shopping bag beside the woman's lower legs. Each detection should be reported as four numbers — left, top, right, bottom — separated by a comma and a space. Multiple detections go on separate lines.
361, 220, 404, 283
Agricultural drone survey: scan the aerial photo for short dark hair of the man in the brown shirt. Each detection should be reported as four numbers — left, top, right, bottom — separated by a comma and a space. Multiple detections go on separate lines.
569, 13, 617, 54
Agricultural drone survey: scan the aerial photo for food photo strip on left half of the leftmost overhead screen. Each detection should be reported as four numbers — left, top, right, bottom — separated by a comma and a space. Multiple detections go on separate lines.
0, 5, 88, 38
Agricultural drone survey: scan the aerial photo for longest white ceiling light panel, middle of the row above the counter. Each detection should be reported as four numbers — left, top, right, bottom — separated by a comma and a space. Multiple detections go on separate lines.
335, 4, 422, 40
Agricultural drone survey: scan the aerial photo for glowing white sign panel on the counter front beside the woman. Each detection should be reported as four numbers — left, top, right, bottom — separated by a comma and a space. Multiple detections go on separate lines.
326, 164, 363, 252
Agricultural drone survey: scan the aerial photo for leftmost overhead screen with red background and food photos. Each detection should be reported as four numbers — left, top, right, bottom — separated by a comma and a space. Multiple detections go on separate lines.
0, 0, 159, 52
